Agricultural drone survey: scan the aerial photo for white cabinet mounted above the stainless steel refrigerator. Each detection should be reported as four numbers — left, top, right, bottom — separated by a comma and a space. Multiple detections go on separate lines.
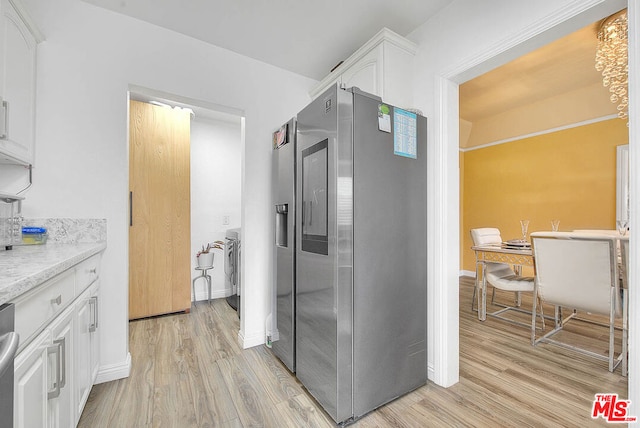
309, 28, 417, 108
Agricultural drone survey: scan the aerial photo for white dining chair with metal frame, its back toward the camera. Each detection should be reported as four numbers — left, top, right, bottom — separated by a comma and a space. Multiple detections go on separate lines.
531, 232, 628, 374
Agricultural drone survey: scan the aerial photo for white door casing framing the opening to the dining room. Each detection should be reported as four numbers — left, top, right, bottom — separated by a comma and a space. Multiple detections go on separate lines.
429, 1, 640, 413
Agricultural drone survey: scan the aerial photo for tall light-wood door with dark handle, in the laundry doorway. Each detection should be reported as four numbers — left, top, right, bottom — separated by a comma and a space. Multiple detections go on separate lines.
129, 101, 191, 319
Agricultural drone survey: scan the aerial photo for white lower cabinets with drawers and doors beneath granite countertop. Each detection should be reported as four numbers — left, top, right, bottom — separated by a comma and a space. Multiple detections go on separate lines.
14, 252, 100, 428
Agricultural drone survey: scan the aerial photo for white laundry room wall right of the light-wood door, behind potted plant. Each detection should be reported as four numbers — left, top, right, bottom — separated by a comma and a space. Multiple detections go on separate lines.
191, 115, 242, 300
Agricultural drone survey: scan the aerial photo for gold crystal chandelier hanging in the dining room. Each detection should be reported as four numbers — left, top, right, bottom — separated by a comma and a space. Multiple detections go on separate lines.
596, 9, 629, 119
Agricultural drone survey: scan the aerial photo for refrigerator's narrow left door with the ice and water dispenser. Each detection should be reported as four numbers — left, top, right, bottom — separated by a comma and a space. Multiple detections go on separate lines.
271, 119, 296, 372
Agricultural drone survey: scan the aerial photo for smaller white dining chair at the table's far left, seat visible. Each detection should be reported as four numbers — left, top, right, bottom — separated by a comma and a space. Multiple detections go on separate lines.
471, 227, 544, 328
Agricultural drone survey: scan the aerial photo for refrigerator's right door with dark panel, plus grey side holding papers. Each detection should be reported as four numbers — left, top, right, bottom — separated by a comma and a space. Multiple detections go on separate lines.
296, 86, 427, 423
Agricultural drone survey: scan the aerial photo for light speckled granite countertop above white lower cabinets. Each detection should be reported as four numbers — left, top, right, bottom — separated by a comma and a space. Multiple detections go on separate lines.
0, 241, 107, 305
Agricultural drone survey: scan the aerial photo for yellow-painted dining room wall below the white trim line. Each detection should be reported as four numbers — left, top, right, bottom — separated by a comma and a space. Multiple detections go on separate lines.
460, 119, 629, 271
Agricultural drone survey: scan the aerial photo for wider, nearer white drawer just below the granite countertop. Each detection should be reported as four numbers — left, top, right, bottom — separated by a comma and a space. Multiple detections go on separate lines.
15, 269, 75, 349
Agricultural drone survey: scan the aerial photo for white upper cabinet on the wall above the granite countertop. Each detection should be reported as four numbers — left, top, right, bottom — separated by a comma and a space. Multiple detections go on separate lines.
0, 0, 43, 165
